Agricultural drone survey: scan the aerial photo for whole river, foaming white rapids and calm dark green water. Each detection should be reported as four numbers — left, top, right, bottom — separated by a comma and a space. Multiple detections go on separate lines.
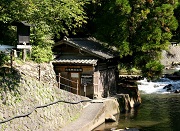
95, 79, 180, 131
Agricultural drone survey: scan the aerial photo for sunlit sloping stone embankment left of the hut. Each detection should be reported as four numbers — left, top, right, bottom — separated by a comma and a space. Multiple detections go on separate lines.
0, 62, 88, 131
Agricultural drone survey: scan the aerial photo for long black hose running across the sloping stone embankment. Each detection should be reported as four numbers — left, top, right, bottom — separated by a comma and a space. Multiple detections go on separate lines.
0, 99, 92, 124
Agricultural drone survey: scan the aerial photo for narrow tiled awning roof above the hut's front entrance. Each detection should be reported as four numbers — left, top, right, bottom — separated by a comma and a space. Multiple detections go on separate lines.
52, 59, 97, 65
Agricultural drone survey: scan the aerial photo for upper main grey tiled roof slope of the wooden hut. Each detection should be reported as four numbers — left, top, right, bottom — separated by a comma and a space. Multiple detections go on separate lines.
57, 38, 117, 59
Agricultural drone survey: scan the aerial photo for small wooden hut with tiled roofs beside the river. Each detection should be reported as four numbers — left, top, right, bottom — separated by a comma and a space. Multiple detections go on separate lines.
52, 37, 118, 98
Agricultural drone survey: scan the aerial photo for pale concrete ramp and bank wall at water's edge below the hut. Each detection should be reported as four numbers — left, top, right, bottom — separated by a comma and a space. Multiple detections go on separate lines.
62, 97, 120, 131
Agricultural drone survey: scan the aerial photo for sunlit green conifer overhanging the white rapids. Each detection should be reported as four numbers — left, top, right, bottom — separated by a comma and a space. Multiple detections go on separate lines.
131, 1, 178, 78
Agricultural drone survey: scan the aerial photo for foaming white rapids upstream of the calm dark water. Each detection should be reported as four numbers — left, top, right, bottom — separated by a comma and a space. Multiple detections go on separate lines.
138, 78, 180, 94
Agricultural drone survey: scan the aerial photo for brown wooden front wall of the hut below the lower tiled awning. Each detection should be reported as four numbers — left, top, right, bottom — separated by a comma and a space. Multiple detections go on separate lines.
54, 65, 94, 97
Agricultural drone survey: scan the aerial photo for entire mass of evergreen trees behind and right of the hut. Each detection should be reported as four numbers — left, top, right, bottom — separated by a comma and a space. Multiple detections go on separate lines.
84, 0, 178, 78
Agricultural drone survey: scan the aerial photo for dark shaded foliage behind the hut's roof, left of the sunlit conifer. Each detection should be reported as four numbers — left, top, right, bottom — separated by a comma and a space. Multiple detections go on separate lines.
87, 0, 131, 48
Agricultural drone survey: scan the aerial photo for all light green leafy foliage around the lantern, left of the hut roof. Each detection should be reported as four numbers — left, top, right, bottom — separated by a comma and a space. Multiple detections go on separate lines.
0, 0, 86, 62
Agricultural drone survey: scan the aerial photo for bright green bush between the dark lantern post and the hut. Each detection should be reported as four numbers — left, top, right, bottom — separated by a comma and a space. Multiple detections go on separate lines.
31, 22, 54, 63
